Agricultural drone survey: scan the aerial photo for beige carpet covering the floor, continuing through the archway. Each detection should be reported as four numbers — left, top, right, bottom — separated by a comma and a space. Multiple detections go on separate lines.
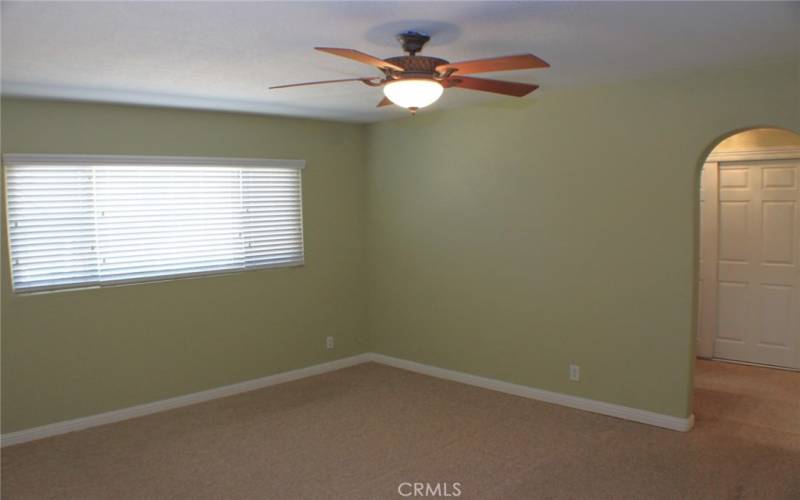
2, 361, 800, 500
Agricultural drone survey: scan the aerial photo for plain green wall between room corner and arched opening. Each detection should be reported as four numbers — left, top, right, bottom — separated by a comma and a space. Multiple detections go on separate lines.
367, 64, 800, 417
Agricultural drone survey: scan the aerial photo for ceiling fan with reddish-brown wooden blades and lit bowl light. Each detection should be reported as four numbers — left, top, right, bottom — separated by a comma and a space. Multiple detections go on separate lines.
270, 31, 550, 113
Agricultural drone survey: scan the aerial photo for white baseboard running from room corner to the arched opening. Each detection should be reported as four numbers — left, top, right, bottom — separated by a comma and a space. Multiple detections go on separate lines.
367, 353, 694, 432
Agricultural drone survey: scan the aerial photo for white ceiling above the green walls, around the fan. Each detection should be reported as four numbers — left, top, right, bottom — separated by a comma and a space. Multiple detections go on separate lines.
1, 1, 800, 122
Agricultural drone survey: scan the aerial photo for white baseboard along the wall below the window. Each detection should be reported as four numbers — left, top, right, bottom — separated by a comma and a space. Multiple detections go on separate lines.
0, 354, 370, 447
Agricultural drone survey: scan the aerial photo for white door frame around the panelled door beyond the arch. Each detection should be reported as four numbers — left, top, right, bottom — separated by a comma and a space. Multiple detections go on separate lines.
695, 146, 800, 359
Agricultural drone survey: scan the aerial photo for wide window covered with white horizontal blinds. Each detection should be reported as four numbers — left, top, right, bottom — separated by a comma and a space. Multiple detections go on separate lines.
4, 155, 304, 291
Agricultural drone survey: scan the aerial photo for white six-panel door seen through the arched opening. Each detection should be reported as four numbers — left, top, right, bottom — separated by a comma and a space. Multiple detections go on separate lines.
714, 160, 800, 368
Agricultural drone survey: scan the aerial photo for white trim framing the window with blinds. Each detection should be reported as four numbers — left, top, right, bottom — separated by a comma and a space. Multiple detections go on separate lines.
2, 153, 306, 296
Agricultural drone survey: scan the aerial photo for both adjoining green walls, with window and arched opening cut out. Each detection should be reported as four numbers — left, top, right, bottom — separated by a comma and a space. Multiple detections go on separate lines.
0, 58, 800, 433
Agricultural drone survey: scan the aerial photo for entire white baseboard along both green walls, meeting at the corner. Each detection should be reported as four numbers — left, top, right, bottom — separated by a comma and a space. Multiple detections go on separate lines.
0, 353, 694, 446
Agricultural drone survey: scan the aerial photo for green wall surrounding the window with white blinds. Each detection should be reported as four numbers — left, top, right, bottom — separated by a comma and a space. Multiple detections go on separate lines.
0, 99, 366, 433
